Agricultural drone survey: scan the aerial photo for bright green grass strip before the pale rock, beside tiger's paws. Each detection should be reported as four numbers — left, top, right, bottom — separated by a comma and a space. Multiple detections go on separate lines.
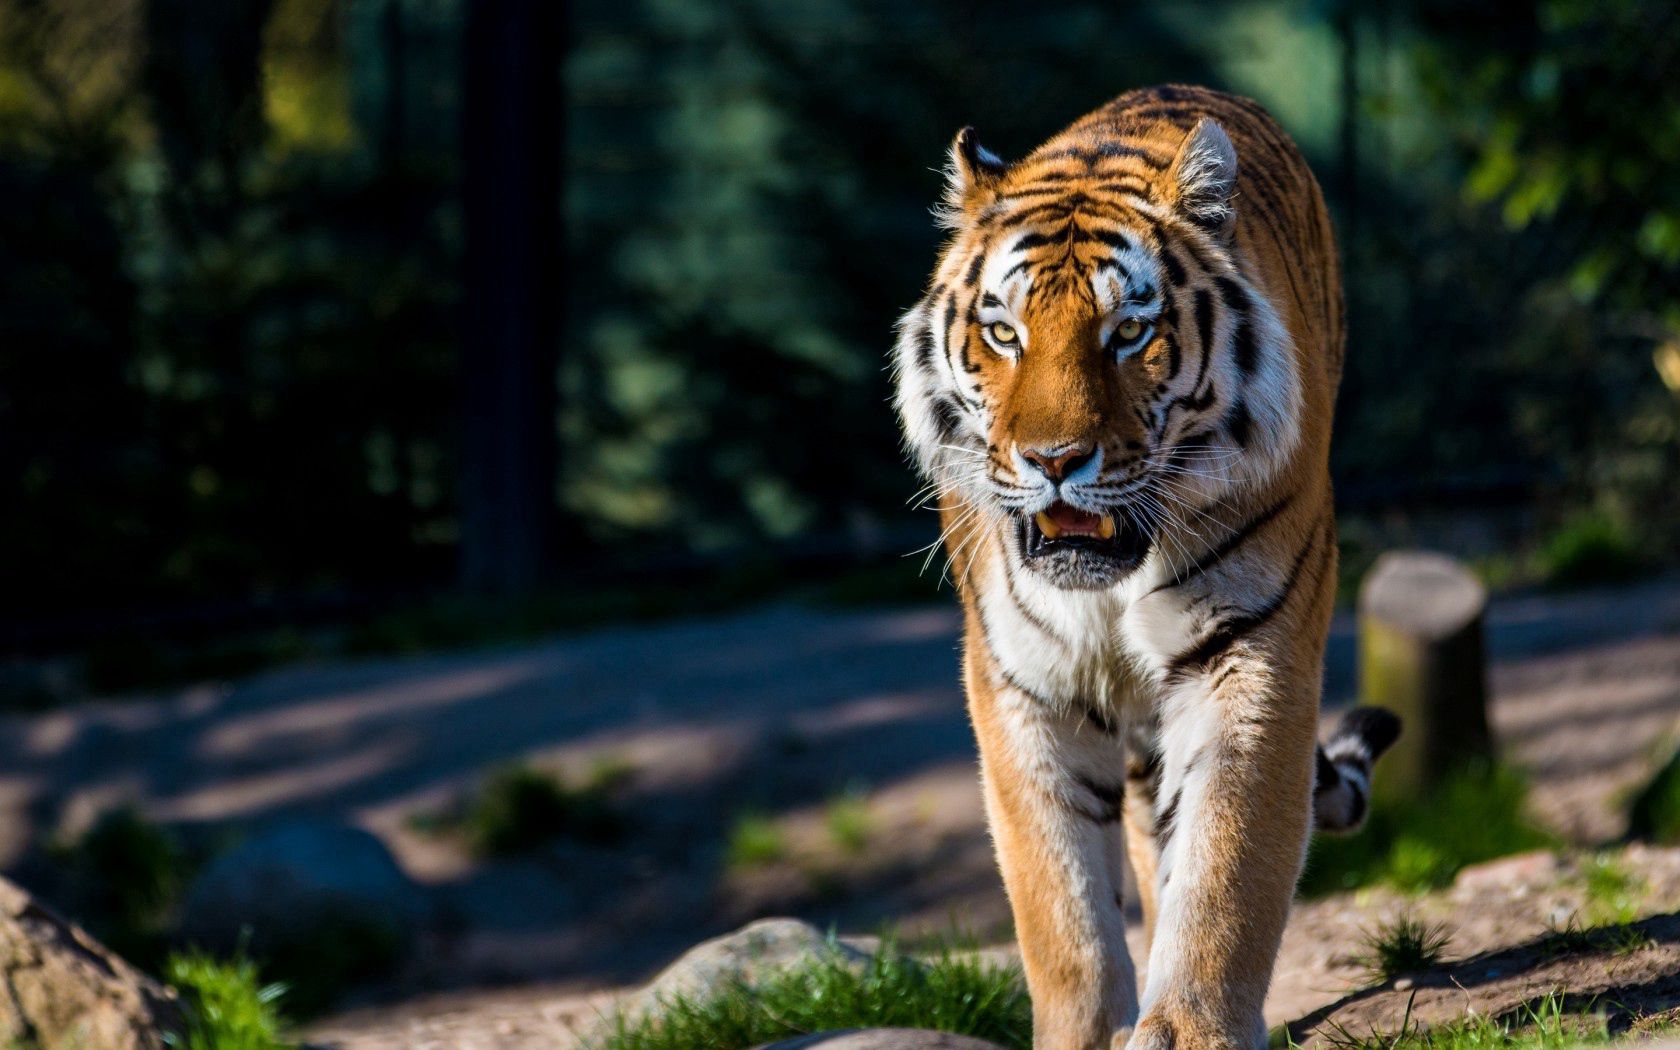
588, 942, 1032, 1050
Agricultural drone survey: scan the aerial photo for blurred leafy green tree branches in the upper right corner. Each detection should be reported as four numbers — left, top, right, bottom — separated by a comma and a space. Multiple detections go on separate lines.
1415, 0, 1680, 551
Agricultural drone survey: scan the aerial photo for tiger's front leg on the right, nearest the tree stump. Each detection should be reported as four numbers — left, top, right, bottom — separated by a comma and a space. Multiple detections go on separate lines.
1114, 648, 1319, 1050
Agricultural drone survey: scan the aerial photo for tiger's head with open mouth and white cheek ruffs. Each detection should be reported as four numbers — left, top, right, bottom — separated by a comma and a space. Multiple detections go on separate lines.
894, 119, 1300, 590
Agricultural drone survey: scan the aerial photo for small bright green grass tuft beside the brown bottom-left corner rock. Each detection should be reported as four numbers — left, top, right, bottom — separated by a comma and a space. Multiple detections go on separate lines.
163, 953, 291, 1050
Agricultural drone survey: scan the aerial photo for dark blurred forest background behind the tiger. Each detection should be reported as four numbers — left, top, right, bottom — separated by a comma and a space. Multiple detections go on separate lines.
0, 0, 1680, 672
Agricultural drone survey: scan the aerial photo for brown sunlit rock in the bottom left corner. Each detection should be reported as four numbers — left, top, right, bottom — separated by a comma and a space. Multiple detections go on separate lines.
0, 879, 183, 1050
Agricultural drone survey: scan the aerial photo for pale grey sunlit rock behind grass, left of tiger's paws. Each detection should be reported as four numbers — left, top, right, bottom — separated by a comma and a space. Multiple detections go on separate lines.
623, 919, 870, 1016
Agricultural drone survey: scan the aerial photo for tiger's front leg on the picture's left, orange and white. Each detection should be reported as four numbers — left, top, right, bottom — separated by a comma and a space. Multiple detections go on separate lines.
966, 642, 1137, 1050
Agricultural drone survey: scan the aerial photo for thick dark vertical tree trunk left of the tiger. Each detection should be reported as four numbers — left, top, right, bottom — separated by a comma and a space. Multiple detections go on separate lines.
460, 0, 564, 595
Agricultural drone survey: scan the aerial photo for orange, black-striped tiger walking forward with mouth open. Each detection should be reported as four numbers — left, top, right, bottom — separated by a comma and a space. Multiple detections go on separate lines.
892, 86, 1399, 1050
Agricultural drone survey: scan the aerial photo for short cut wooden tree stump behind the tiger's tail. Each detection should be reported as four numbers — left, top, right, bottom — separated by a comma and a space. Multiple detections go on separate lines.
1359, 551, 1494, 798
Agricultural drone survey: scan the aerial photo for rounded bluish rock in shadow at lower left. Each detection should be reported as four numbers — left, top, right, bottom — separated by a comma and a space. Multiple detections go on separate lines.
181, 820, 427, 958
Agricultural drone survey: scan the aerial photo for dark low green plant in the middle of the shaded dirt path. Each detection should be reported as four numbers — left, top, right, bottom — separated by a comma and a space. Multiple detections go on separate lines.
462, 766, 623, 857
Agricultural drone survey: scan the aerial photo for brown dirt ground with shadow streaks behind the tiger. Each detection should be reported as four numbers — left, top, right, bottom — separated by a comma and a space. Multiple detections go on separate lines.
0, 580, 1680, 1048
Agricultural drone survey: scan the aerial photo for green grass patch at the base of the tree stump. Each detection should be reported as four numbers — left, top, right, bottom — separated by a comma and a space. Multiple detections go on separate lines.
1300, 764, 1554, 897
